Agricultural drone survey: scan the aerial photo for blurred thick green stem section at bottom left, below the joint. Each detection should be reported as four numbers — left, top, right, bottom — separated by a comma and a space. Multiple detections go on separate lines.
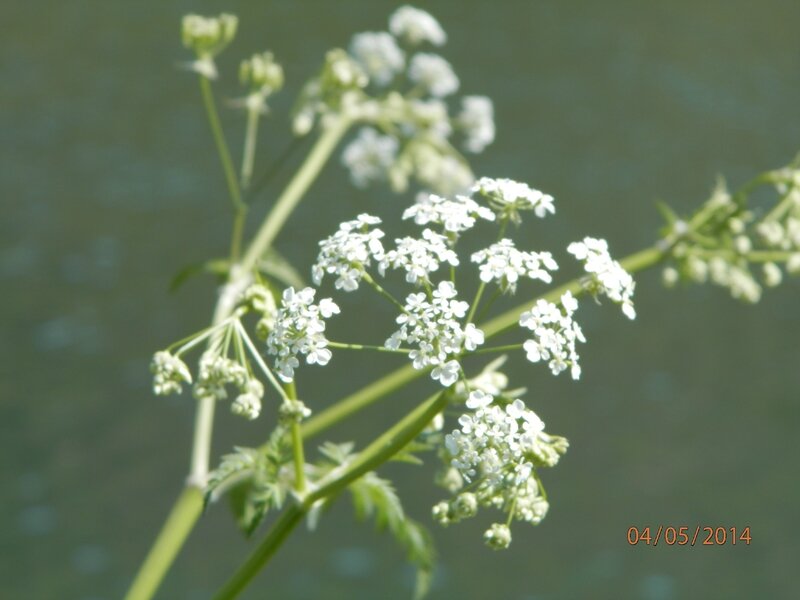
125, 487, 203, 600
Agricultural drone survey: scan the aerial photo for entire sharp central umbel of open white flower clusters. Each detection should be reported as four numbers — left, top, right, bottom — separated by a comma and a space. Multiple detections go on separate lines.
267, 178, 635, 387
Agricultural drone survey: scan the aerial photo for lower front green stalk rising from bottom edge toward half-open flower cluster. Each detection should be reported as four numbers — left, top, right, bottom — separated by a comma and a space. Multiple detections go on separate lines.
214, 392, 448, 600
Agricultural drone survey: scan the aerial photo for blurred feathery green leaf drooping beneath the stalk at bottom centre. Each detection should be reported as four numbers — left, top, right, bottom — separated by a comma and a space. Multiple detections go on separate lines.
349, 471, 436, 598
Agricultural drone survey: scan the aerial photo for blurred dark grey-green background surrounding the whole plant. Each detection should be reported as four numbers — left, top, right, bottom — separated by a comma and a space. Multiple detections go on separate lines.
0, 0, 800, 600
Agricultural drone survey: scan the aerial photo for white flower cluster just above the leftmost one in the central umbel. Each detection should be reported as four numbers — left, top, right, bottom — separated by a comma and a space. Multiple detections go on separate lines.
311, 214, 384, 292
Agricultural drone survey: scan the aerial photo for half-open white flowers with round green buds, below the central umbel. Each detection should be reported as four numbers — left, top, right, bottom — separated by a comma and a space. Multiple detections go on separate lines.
434, 390, 568, 548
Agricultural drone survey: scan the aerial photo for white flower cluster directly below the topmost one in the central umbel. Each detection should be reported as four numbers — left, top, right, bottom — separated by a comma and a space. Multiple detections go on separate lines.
472, 239, 558, 293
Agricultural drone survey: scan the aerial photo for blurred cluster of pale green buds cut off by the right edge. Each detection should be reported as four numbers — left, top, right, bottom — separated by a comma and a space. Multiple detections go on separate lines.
663, 164, 800, 303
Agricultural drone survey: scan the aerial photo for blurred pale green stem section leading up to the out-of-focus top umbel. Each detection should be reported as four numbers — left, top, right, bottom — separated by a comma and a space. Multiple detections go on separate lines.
242, 117, 351, 270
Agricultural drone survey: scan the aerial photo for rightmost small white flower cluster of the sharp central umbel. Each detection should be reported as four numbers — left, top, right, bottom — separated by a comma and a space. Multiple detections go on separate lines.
567, 237, 636, 319
